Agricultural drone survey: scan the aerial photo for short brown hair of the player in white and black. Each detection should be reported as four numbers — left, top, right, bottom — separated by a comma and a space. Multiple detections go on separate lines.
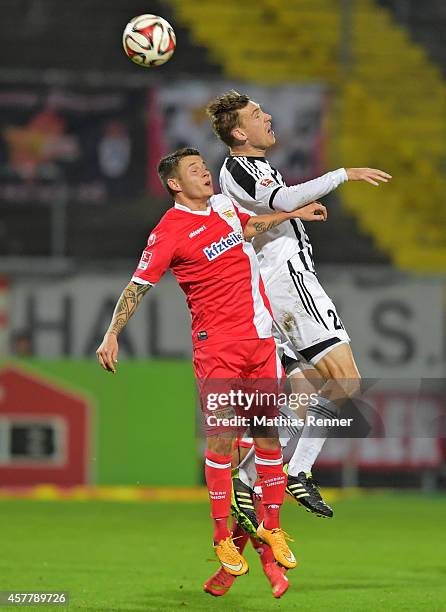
206, 89, 249, 147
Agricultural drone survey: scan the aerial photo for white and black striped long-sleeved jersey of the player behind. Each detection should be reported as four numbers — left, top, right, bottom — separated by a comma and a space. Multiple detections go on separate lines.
220, 156, 348, 282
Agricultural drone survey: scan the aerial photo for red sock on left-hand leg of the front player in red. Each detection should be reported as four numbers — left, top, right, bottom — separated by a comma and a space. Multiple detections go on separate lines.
205, 449, 232, 542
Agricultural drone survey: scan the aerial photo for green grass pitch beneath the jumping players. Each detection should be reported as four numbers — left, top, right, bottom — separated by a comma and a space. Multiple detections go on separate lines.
0, 494, 446, 612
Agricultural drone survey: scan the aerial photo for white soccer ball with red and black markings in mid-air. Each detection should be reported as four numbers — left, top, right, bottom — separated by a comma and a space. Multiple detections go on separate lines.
122, 15, 176, 68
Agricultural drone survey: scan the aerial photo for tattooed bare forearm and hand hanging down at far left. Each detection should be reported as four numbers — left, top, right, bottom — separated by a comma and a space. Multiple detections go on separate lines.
96, 281, 152, 374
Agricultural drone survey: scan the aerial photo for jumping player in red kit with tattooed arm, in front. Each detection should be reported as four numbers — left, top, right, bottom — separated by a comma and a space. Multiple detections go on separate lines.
97, 149, 325, 576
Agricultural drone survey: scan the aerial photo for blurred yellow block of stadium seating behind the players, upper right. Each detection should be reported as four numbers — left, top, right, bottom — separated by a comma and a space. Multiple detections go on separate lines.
170, 0, 446, 272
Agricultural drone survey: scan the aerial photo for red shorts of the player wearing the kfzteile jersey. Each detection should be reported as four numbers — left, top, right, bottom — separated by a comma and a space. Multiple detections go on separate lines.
194, 338, 283, 436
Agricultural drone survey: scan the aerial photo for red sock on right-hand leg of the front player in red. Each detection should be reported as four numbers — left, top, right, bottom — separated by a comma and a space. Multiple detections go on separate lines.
255, 446, 286, 529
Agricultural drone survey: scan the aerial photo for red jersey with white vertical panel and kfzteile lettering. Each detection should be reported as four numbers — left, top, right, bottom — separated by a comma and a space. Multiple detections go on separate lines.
132, 194, 272, 346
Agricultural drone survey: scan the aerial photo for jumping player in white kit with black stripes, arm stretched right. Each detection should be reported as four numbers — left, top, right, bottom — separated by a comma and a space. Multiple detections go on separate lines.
207, 91, 391, 517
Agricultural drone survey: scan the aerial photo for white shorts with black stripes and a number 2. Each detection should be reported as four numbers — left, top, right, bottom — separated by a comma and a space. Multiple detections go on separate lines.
265, 260, 350, 375
